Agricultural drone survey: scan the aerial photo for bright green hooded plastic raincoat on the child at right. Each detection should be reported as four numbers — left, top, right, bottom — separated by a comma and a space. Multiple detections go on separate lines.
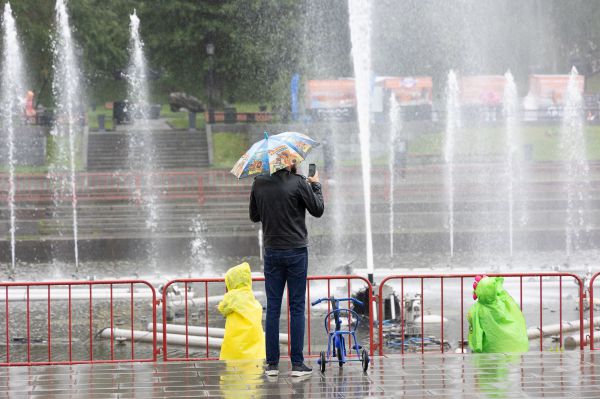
467, 277, 529, 353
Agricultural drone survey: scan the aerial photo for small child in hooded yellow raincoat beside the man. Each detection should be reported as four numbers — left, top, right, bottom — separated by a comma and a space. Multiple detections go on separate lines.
218, 262, 265, 360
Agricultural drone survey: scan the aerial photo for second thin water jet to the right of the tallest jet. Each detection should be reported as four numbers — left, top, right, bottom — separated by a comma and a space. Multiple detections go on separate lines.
444, 71, 461, 258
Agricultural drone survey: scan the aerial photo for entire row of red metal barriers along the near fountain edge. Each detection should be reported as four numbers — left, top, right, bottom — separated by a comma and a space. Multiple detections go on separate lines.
0, 273, 600, 366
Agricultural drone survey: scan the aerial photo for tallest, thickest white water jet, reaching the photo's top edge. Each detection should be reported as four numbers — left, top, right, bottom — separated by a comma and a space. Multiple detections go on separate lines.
348, 0, 374, 281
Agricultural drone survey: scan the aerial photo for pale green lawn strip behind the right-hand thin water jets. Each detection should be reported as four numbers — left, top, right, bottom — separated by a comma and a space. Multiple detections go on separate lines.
408, 125, 600, 162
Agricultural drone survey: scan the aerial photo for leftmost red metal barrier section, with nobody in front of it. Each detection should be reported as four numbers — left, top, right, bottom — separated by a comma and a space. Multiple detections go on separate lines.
0, 280, 157, 366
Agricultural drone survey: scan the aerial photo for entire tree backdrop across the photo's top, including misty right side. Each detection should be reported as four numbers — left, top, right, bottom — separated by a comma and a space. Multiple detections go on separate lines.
13, 0, 600, 108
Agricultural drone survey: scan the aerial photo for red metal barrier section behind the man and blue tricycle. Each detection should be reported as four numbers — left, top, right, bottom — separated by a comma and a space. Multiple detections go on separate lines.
162, 276, 375, 361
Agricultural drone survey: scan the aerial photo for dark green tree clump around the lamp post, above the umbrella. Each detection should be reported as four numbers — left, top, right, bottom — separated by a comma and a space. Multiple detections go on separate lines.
140, 0, 308, 104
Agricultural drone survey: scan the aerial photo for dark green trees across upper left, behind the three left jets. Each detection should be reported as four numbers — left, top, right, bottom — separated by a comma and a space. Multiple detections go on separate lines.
8, 0, 314, 103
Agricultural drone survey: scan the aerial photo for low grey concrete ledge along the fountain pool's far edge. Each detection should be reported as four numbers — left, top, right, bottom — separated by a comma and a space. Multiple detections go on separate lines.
0, 229, 600, 262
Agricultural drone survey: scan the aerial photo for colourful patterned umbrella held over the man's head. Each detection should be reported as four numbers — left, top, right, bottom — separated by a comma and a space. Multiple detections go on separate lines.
231, 132, 319, 179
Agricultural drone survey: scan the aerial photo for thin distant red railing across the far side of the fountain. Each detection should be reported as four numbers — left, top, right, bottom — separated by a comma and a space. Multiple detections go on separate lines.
0, 163, 600, 203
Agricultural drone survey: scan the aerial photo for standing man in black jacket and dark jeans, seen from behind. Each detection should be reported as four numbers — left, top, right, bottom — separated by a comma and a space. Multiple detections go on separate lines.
250, 165, 324, 377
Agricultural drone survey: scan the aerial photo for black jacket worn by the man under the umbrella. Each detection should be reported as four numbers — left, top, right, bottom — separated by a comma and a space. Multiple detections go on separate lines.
250, 169, 325, 249
